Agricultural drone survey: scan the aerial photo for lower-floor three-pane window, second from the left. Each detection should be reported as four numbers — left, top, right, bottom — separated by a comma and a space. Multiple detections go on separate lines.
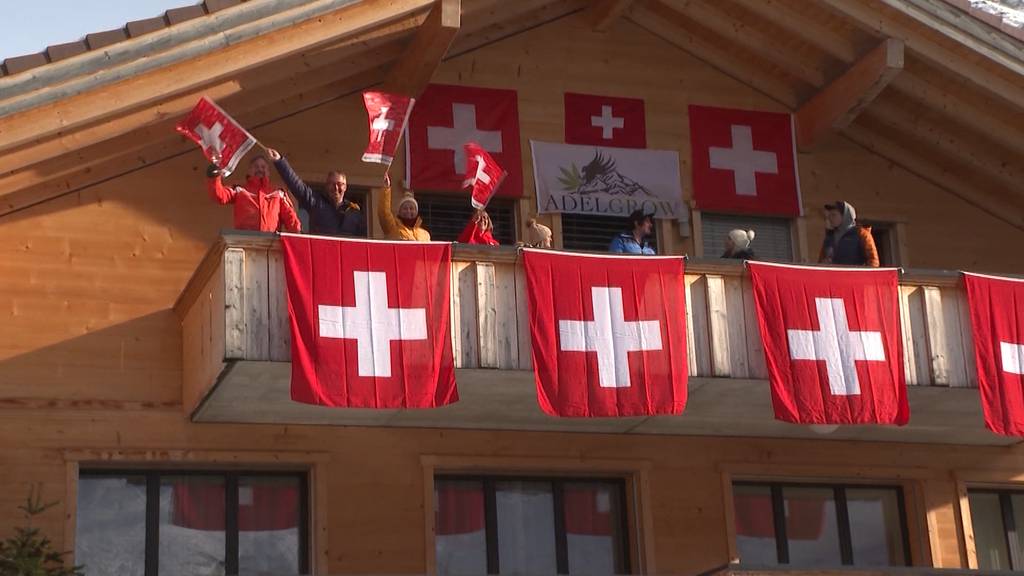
434, 476, 630, 575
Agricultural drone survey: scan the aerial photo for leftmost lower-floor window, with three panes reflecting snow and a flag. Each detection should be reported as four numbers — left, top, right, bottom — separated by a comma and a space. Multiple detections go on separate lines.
75, 470, 309, 576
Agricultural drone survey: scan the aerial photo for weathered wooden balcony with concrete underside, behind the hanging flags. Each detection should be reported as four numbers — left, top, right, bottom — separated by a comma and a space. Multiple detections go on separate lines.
175, 233, 999, 445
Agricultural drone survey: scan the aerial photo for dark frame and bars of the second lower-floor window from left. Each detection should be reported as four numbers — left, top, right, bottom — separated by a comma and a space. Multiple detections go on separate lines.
430, 471, 633, 575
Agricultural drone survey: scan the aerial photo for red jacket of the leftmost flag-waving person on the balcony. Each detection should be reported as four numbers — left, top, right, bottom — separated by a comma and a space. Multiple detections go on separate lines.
208, 176, 302, 232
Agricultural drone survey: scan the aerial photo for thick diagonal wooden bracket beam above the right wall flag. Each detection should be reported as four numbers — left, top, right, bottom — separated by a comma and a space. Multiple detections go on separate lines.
796, 38, 903, 152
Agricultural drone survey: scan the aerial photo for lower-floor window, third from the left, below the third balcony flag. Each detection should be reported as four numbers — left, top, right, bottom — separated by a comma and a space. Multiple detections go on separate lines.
732, 482, 910, 567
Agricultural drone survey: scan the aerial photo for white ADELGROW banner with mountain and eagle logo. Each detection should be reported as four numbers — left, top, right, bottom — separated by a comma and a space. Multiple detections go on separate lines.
529, 140, 689, 222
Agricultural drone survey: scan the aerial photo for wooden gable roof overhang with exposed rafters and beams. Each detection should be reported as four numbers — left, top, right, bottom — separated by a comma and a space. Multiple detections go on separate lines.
0, 0, 1024, 229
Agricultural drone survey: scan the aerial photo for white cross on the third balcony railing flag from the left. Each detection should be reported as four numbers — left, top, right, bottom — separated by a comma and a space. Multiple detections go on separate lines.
785, 298, 886, 396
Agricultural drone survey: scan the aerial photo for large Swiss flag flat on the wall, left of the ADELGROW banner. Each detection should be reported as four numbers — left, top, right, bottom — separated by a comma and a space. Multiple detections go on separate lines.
406, 84, 522, 198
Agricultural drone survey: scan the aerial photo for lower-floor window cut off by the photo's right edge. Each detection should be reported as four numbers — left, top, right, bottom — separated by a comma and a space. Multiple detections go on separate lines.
968, 490, 1024, 572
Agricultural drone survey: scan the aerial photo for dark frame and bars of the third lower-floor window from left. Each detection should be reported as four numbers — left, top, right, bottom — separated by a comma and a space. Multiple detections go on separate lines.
729, 480, 913, 568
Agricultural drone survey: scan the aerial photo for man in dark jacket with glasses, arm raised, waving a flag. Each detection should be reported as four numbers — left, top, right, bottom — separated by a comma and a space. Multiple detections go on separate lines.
267, 149, 367, 237
